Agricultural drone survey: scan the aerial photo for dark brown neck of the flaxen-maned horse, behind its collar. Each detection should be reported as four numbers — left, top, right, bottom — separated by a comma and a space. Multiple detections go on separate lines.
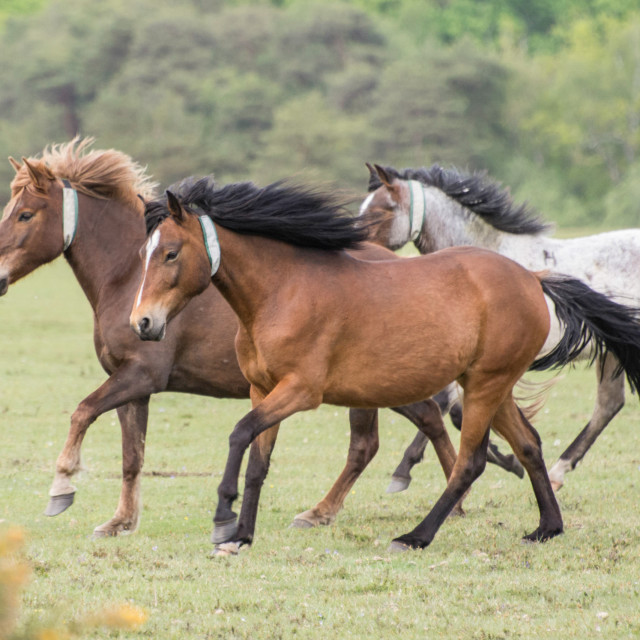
65, 193, 145, 311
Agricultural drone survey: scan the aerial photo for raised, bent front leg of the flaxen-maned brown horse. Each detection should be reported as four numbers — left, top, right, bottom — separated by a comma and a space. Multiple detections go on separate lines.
45, 363, 163, 516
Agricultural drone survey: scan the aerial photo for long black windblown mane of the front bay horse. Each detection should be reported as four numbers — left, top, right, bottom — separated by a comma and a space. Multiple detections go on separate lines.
145, 176, 368, 251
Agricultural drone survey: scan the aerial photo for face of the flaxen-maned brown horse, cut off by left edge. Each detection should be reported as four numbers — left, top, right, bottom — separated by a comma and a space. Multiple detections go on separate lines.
0, 165, 64, 295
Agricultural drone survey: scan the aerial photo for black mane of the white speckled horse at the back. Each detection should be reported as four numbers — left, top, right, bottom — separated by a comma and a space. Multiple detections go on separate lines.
368, 164, 553, 235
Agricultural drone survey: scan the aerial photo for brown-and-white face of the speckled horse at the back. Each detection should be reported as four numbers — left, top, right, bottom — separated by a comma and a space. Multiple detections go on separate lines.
360, 181, 411, 251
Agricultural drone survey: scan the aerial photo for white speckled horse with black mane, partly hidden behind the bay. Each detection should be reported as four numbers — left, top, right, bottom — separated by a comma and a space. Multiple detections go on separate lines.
360, 165, 640, 491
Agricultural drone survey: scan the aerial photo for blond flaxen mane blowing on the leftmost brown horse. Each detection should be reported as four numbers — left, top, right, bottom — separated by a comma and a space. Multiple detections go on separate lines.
11, 136, 157, 209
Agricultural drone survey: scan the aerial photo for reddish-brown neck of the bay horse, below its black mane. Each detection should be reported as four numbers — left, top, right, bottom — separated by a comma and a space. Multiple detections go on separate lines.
213, 225, 304, 330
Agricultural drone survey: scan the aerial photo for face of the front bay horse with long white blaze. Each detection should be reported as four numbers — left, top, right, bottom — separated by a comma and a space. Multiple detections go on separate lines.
129, 215, 211, 340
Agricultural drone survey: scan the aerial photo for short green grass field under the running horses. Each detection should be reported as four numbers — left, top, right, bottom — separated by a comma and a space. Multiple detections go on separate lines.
0, 260, 640, 640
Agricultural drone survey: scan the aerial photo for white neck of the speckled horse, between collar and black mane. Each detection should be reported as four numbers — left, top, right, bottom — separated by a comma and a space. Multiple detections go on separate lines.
416, 187, 514, 253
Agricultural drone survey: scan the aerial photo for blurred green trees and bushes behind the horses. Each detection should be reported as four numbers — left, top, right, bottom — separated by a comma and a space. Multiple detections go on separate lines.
0, 0, 640, 228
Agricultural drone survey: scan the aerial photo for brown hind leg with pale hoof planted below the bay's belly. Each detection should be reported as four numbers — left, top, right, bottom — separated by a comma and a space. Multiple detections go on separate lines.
292, 409, 379, 528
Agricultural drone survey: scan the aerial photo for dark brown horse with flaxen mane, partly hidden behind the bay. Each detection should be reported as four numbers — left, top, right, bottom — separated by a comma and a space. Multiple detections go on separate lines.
0, 138, 456, 536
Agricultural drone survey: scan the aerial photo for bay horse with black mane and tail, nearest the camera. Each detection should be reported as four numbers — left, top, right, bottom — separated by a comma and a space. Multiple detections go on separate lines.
130, 179, 640, 554
